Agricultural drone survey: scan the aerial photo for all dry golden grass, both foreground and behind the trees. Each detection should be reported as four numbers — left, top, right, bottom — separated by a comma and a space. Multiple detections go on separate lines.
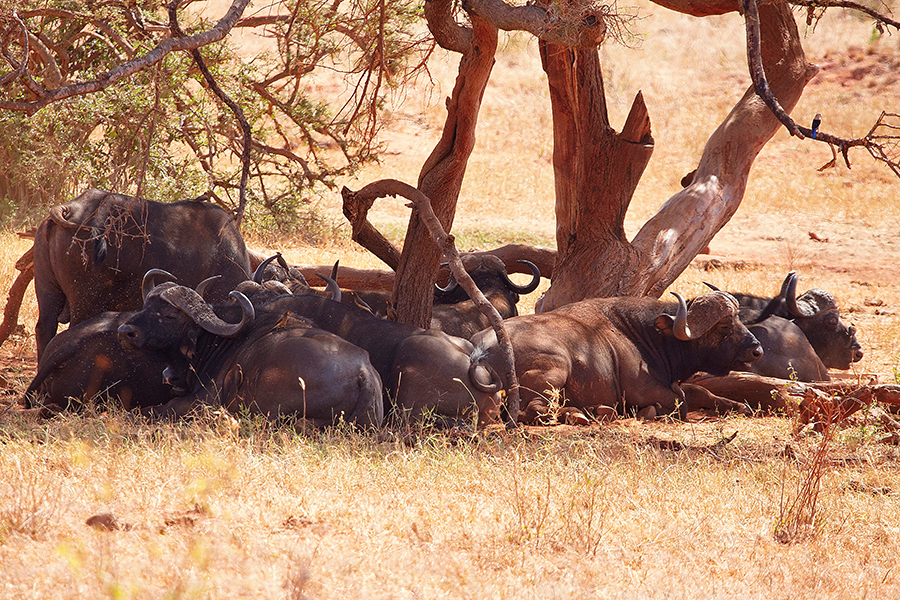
0, 3, 900, 599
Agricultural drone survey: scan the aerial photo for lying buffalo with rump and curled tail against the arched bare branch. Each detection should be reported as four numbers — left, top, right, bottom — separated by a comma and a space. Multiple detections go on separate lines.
261, 296, 501, 423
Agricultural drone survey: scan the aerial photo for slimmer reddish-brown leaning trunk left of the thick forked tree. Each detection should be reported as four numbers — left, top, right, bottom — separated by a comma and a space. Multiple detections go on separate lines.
393, 10, 497, 328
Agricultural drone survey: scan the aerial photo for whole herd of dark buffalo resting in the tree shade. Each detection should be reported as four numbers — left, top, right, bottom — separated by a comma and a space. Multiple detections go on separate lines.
25, 190, 862, 427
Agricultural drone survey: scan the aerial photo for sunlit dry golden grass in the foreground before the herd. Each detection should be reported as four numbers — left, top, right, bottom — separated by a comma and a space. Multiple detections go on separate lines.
0, 413, 900, 599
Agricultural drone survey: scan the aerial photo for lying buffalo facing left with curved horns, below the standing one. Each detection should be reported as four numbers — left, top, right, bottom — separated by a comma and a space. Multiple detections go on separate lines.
118, 282, 384, 427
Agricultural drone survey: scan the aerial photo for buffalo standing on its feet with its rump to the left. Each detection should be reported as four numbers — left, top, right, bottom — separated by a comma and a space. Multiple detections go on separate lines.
34, 189, 250, 359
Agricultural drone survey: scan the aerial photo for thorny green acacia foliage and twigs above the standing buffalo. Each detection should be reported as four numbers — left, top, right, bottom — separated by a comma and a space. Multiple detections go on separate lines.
0, 0, 432, 237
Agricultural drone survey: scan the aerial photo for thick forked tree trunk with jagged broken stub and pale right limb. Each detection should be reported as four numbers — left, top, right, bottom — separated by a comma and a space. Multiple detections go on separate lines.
538, 2, 818, 311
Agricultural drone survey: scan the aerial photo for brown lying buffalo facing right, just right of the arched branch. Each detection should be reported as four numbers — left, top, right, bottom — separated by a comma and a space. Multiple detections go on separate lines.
472, 292, 762, 420
